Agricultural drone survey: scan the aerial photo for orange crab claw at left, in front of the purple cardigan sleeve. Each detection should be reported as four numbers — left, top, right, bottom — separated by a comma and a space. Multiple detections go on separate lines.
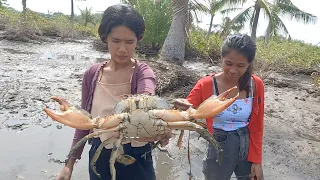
44, 96, 97, 130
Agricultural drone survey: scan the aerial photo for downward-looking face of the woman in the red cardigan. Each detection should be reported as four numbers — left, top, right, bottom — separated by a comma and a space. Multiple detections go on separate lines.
222, 50, 250, 80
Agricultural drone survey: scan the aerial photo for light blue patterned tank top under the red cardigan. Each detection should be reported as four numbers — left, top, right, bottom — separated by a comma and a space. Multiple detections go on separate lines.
212, 76, 253, 131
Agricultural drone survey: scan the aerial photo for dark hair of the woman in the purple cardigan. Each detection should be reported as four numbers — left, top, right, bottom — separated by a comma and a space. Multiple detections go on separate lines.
98, 4, 145, 42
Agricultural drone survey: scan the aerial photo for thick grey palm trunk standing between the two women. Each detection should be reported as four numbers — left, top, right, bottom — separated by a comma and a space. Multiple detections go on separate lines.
160, 0, 189, 65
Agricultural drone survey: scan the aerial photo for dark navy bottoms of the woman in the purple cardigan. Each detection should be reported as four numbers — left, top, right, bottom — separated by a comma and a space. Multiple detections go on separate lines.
89, 138, 156, 180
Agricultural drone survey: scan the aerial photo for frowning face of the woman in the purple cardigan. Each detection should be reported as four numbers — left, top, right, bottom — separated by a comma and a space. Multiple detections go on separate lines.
107, 26, 137, 64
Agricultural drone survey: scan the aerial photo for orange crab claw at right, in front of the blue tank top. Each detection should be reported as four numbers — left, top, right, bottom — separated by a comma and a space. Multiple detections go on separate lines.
191, 86, 239, 119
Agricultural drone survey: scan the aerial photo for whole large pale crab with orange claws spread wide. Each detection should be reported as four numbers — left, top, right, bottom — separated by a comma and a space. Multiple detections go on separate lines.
44, 87, 239, 180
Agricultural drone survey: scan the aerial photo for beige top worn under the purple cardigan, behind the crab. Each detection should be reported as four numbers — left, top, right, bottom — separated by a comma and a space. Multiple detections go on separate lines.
91, 69, 147, 149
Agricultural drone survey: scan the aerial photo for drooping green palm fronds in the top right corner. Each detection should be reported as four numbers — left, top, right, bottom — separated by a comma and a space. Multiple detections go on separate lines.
232, 0, 317, 41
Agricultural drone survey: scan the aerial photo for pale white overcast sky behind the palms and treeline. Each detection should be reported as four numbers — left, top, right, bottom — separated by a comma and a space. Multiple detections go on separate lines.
7, 0, 320, 44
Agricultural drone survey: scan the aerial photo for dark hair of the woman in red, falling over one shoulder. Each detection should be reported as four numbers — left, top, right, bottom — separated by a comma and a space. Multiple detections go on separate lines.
221, 34, 256, 91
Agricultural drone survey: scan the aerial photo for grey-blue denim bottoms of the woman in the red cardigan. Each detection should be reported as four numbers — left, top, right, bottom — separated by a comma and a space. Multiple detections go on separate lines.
202, 127, 252, 180
